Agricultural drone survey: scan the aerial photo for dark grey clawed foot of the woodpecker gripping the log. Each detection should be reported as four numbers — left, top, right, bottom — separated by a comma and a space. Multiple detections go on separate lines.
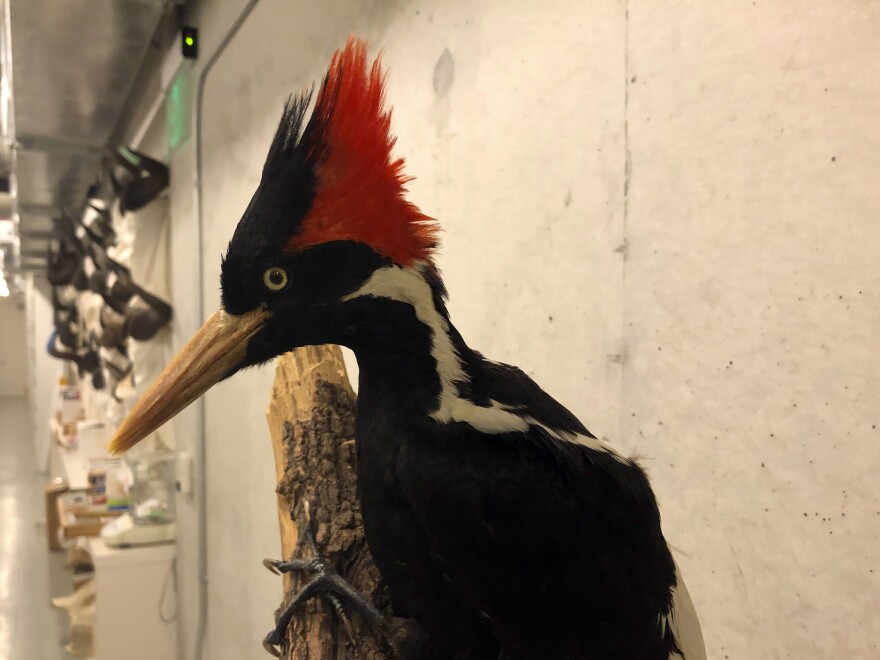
263, 502, 390, 657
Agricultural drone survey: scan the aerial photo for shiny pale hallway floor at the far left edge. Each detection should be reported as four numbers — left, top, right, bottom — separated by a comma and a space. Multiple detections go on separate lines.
0, 399, 75, 660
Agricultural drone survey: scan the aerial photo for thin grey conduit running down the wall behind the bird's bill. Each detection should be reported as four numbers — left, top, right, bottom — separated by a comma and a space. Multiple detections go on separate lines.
192, 0, 260, 660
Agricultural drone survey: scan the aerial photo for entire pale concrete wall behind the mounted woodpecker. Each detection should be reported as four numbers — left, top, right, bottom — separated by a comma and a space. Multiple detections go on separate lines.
120, 0, 880, 660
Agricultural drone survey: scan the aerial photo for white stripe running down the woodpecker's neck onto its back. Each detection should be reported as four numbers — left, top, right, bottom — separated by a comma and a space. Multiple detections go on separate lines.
343, 264, 629, 463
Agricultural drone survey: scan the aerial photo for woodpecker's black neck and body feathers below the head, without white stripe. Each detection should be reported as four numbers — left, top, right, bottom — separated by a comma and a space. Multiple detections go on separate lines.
344, 270, 675, 660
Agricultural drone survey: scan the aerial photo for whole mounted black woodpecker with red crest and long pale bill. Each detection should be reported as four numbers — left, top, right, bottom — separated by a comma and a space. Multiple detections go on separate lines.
111, 38, 705, 660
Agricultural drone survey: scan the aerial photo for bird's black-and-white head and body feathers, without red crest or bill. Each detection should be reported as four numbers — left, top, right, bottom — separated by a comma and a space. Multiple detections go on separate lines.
211, 38, 704, 660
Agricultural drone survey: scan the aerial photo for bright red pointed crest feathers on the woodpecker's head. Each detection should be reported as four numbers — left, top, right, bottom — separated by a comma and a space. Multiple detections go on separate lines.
287, 36, 439, 266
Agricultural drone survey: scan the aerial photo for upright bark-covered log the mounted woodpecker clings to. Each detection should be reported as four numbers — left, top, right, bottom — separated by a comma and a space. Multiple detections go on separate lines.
267, 346, 391, 660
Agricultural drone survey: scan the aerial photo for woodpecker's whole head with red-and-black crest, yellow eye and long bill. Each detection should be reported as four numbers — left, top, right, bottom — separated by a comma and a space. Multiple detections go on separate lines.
110, 38, 438, 453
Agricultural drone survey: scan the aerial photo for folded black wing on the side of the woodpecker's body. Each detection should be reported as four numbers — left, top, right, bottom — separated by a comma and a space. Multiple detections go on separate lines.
397, 416, 675, 660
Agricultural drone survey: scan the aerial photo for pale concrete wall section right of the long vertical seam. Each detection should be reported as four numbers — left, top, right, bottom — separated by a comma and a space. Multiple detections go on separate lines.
623, 2, 880, 658
